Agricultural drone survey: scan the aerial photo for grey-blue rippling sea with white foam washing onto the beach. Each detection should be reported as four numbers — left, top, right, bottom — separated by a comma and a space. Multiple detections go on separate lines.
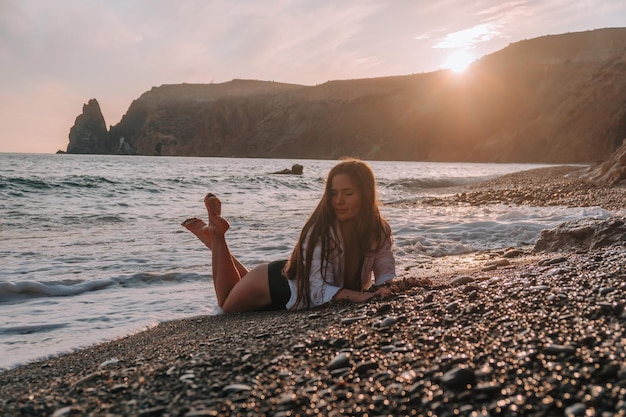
0, 153, 612, 370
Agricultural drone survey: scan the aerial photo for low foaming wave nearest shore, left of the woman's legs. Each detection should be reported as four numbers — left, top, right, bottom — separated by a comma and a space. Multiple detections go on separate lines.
0, 272, 208, 303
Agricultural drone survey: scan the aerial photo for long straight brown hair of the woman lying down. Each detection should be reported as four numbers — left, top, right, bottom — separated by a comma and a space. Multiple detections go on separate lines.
284, 159, 391, 307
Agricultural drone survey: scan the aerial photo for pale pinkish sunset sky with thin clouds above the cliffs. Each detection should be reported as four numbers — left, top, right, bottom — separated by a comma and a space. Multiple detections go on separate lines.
0, 0, 626, 153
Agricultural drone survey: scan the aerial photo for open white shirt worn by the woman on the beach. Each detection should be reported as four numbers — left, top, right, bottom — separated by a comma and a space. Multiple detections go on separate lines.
285, 224, 396, 309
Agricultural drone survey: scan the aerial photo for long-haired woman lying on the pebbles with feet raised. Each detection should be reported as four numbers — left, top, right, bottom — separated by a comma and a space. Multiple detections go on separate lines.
182, 159, 424, 313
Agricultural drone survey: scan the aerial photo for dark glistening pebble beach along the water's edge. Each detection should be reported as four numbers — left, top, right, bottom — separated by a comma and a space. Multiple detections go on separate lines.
0, 168, 626, 417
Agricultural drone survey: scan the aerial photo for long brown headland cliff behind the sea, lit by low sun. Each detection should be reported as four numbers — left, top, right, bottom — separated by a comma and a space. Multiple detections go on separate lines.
67, 28, 626, 163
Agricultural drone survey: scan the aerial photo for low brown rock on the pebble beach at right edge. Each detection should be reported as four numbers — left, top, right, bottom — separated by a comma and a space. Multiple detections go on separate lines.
534, 217, 626, 252
